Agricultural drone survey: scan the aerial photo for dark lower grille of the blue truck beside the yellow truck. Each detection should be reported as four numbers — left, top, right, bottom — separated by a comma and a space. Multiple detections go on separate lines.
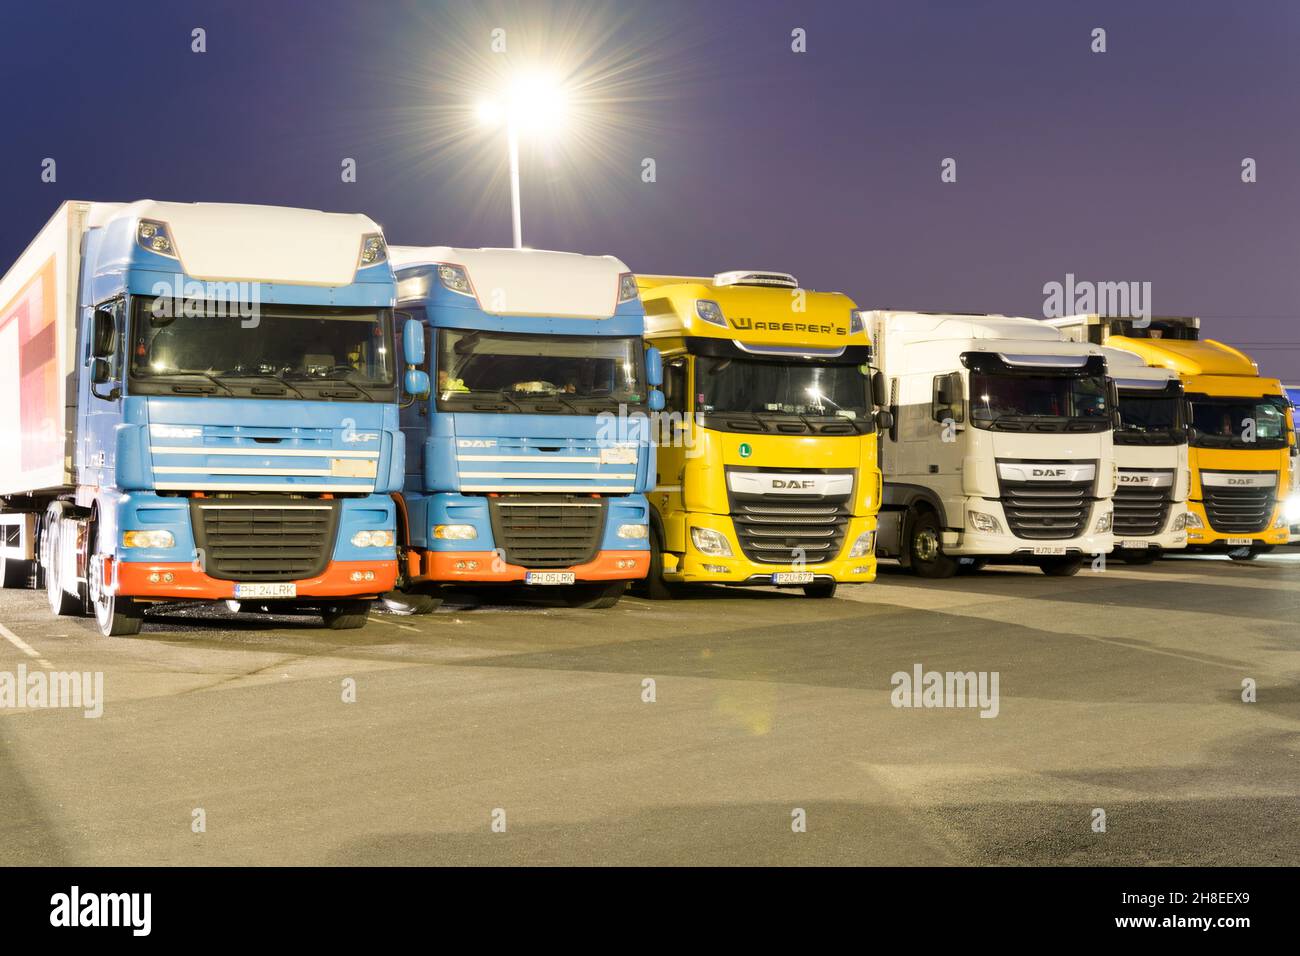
488, 494, 606, 568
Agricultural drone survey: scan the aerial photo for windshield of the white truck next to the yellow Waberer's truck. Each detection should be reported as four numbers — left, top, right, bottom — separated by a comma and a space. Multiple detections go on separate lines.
970, 367, 1112, 432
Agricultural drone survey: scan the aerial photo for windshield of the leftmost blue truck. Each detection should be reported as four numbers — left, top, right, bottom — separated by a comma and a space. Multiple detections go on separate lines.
130, 297, 395, 401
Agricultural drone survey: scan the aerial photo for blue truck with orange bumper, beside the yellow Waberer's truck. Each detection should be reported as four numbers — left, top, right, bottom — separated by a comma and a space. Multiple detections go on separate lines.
390, 246, 663, 607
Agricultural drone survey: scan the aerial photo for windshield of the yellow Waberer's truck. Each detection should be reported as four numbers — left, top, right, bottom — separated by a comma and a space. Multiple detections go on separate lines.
696, 355, 871, 421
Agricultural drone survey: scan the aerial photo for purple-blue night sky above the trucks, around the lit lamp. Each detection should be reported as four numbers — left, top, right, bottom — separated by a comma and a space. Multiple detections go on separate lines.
0, 0, 1300, 381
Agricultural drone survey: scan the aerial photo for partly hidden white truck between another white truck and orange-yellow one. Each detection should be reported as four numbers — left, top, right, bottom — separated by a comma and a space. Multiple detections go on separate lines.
1102, 349, 1191, 564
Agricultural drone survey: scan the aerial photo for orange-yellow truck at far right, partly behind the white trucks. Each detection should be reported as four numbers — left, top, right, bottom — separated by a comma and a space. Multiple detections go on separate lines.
1048, 315, 1297, 561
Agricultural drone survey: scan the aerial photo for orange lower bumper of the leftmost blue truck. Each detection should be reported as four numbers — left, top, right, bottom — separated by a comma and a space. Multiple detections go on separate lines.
114, 561, 398, 601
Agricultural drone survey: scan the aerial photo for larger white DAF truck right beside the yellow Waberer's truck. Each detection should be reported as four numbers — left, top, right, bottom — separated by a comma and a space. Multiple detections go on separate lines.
866, 311, 1115, 578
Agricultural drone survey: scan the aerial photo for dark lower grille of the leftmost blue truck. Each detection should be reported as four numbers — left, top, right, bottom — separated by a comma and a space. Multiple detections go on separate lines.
190, 498, 341, 581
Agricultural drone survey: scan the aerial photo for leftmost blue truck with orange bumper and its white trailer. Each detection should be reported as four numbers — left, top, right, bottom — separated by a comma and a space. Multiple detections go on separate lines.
0, 200, 428, 635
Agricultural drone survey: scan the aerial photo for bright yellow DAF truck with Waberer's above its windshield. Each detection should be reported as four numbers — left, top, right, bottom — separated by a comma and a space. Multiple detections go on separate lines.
637, 271, 889, 598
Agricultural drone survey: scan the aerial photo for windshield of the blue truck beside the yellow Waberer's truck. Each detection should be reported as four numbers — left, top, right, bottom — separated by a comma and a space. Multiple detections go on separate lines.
434, 329, 646, 415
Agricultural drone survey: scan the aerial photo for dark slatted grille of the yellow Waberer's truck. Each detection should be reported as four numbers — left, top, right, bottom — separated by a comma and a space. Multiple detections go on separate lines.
728, 472, 853, 564
